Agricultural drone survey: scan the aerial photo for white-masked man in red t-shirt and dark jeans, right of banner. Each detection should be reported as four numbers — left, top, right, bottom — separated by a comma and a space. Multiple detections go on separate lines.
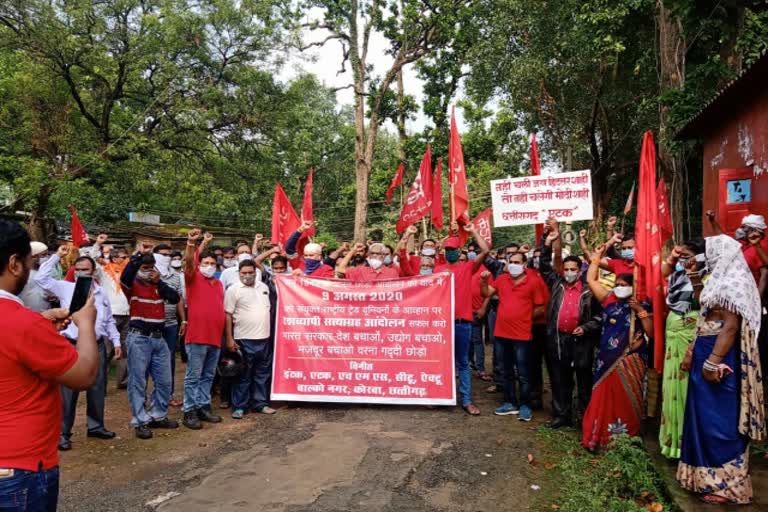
480, 252, 547, 421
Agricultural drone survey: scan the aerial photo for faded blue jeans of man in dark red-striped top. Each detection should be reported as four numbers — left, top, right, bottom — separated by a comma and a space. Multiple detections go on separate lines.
127, 331, 171, 427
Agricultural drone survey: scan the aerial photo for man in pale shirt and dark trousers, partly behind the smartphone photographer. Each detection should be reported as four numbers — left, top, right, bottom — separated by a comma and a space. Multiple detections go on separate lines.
34, 245, 122, 450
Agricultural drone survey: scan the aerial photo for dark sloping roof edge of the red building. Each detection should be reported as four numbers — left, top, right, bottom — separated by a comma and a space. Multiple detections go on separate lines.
675, 50, 768, 140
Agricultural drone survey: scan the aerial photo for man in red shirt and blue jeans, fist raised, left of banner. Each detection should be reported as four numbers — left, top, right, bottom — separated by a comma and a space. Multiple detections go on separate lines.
182, 229, 226, 430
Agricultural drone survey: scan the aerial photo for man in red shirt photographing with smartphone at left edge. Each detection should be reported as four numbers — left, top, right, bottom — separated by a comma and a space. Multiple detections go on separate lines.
0, 220, 99, 511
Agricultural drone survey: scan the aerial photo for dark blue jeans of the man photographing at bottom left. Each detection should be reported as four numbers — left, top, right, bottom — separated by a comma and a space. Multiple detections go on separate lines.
0, 466, 59, 512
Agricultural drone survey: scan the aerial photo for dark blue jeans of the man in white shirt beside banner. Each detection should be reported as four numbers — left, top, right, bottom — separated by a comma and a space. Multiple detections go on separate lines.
232, 338, 272, 410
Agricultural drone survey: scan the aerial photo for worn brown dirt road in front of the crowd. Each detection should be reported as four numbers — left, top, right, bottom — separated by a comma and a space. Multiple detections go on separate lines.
59, 365, 548, 512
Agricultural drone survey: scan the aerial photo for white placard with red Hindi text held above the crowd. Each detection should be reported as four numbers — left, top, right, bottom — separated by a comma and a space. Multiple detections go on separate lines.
491, 170, 593, 228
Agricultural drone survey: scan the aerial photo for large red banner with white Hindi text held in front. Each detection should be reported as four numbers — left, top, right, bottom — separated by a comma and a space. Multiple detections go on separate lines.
272, 273, 456, 405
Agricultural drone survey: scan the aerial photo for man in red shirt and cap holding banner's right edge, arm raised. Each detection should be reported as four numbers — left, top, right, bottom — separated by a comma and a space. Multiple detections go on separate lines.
434, 222, 490, 416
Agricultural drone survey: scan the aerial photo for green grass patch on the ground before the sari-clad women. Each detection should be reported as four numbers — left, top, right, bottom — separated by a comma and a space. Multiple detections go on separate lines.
536, 428, 678, 512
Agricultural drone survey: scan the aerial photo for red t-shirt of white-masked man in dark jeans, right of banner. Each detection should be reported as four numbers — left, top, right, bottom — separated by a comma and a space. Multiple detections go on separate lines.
493, 273, 547, 341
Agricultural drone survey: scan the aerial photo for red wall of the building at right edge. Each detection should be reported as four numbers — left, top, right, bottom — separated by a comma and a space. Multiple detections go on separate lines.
702, 87, 768, 236
